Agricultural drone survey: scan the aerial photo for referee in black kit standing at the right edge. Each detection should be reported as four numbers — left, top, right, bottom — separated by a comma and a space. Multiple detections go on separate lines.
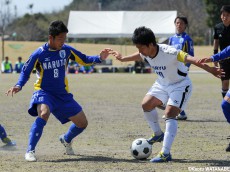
213, 5, 230, 98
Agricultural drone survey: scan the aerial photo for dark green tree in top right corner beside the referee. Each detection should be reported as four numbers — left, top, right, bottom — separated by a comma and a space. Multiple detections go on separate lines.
204, 0, 230, 28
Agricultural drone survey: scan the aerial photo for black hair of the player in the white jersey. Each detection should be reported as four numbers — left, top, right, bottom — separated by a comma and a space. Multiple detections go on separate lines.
132, 26, 156, 46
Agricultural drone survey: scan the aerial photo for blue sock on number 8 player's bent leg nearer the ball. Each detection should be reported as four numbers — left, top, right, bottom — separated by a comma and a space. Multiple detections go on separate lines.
64, 124, 85, 143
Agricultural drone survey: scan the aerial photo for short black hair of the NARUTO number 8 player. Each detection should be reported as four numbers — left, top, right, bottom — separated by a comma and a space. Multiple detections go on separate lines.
49, 20, 68, 37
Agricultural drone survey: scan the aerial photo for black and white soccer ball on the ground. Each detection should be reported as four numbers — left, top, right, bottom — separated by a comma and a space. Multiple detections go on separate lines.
130, 138, 152, 160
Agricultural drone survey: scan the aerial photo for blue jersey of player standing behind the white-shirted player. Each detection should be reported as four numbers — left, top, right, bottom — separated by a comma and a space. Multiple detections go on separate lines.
169, 32, 194, 67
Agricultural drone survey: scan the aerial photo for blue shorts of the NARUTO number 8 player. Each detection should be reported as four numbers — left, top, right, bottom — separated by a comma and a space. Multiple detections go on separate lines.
28, 90, 82, 124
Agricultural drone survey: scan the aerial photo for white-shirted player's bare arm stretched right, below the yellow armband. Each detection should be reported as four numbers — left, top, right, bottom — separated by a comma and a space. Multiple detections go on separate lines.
185, 55, 225, 78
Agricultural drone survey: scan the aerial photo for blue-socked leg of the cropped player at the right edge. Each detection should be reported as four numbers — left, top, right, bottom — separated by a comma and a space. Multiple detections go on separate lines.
221, 91, 230, 152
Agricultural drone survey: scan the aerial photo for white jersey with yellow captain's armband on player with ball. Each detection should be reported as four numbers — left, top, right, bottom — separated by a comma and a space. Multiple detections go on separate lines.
140, 44, 190, 86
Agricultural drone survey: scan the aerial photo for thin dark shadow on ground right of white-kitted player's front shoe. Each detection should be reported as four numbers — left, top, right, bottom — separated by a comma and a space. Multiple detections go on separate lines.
173, 158, 230, 166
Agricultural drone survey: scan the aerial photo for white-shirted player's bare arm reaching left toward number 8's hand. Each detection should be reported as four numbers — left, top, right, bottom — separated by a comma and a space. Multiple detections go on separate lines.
110, 51, 142, 62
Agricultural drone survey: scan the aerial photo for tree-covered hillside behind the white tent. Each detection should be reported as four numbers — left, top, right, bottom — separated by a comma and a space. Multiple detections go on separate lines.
0, 0, 229, 45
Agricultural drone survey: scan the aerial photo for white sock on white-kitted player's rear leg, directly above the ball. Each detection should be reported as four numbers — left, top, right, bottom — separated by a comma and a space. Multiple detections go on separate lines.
144, 109, 162, 136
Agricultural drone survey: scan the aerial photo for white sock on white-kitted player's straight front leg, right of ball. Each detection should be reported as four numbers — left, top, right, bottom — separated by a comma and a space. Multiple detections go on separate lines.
161, 119, 177, 154
